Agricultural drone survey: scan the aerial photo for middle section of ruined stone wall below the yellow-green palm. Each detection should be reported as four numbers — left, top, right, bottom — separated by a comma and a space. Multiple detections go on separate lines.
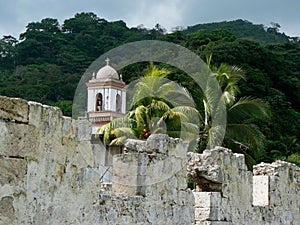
97, 135, 194, 225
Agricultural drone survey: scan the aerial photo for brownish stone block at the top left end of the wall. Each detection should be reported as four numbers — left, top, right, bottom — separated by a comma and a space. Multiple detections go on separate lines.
0, 96, 28, 123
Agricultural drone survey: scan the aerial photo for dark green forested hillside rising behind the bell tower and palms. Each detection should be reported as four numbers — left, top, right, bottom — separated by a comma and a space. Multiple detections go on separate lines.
0, 13, 300, 165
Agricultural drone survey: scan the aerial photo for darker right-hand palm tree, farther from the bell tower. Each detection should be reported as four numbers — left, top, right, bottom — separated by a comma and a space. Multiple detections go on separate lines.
199, 55, 270, 168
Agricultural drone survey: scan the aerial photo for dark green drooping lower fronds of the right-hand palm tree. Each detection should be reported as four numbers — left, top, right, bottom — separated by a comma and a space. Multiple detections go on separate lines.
224, 97, 270, 167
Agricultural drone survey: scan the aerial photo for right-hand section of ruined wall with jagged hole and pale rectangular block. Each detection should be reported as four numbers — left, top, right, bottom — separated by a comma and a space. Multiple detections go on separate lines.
188, 147, 300, 225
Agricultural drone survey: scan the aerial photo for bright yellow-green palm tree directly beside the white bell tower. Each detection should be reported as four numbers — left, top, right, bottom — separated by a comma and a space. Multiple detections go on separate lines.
99, 63, 200, 145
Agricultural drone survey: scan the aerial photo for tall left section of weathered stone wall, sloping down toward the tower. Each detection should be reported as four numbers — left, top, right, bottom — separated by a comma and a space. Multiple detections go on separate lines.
0, 97, 103, 225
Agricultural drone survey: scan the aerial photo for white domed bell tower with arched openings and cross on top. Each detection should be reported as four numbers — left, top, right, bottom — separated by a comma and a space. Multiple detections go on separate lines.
86, 58, 126, 134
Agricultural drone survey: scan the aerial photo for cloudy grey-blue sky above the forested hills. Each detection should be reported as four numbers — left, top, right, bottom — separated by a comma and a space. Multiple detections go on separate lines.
0, 0, 300, 37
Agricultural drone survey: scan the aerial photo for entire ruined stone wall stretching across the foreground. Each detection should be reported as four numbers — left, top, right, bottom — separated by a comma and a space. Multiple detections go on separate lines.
0, 97, 300, 225
